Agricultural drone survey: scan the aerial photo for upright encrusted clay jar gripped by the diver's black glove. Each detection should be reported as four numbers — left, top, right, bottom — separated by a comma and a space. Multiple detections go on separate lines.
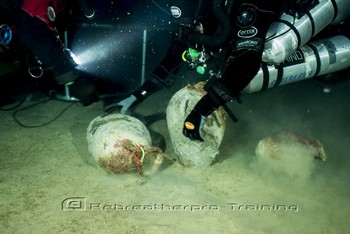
166, 82, 226, 168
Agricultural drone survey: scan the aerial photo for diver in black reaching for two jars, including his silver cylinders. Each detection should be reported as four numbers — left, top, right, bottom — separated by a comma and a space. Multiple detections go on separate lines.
110, 0, 350, 141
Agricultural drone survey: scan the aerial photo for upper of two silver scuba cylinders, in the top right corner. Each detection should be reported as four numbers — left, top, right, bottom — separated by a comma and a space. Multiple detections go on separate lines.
262, 0, 350, 64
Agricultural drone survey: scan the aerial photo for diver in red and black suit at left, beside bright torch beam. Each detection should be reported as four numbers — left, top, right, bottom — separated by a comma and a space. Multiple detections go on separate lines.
0, 0, 98, 106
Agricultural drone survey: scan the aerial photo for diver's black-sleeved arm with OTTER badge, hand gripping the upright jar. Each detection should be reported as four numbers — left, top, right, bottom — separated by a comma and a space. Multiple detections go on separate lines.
183, 0, 283, 141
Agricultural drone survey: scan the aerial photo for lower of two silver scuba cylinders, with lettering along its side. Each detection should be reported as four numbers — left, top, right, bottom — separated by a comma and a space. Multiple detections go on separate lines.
242, 35, 350, 93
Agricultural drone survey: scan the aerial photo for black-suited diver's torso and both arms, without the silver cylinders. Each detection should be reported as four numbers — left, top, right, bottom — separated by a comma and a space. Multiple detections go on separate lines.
108, 0, 286, 140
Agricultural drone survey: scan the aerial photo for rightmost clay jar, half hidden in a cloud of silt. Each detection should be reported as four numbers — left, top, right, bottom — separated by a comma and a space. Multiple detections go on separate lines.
254, 131, 327, 182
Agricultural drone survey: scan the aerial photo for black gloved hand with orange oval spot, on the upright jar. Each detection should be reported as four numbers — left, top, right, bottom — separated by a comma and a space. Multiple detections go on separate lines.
183, 110, 206, 141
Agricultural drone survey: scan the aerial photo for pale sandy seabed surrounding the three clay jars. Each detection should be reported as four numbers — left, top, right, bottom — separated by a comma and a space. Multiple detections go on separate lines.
0, 75, 350, 234
